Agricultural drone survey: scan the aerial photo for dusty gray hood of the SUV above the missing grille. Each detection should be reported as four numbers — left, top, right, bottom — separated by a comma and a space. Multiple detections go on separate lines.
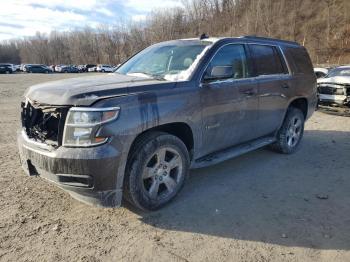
25, 74, 175, 106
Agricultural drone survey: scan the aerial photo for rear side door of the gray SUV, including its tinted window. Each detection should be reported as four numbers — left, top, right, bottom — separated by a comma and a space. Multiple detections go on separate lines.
249, 44, 293, 137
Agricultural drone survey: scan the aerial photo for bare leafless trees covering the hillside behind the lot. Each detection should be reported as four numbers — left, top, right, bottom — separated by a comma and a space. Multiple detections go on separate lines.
0, 0, 350, 65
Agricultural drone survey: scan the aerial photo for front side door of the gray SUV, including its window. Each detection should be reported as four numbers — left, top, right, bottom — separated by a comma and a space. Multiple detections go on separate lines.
201, 44, 258, 155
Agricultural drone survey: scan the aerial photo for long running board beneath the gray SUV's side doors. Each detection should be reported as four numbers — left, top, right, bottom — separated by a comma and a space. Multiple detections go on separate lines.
191, 137, 276, 168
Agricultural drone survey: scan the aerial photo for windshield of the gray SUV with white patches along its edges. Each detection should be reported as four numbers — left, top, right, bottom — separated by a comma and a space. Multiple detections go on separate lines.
116, 40, 212, 81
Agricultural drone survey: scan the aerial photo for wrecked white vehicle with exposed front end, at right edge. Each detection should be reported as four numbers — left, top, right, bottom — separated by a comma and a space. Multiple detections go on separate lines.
317, 66, 350, 106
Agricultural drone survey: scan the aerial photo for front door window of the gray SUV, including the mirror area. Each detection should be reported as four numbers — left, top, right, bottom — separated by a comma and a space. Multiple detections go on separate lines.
205, 44, 249, 79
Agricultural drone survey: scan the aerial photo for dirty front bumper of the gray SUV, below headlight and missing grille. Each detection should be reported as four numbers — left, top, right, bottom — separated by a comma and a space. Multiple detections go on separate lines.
17, 131, 122, 207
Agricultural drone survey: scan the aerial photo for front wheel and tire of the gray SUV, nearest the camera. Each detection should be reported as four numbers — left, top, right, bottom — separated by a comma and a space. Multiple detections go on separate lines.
124, 132, 190, 211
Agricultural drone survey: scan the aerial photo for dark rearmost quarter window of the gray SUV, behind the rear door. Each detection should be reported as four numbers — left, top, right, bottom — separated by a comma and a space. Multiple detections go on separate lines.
287, 48, 314, 74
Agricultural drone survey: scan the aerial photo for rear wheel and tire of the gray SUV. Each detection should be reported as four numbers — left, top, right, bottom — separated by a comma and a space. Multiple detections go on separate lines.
271, 107, 305, 154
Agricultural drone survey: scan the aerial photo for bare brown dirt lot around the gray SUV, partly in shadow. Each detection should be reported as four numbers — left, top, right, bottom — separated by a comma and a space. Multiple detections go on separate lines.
0, 74, 350, 262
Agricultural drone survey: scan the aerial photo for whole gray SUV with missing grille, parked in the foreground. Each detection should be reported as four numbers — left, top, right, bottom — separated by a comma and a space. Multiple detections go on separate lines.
18, 36, 317, 210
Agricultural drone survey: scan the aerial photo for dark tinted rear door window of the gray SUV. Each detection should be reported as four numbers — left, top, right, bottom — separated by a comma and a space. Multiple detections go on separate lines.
249, 45, 288, 76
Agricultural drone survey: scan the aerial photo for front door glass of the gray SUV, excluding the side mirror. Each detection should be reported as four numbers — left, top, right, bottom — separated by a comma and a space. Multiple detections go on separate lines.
207, 44, 249, 79
